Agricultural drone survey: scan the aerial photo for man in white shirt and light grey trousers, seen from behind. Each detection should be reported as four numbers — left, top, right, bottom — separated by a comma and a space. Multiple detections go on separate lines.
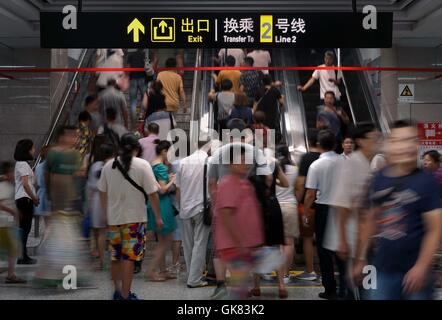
175, 142, 210, 288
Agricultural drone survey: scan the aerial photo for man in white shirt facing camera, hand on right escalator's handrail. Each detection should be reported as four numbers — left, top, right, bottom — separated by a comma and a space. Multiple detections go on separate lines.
298, 51, 343, 101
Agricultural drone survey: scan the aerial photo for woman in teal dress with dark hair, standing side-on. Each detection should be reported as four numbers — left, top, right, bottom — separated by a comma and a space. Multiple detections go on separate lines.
146, 140, 176, 282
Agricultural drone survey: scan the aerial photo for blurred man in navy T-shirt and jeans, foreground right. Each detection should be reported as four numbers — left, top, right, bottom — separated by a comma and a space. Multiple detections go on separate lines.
354, 121, 442, 300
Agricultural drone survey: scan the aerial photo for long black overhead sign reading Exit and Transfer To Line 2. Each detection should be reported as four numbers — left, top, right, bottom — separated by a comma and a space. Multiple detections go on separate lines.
40, 12, 393, 48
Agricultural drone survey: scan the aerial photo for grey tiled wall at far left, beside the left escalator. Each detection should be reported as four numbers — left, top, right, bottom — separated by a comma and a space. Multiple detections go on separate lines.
0, 48, 51, 160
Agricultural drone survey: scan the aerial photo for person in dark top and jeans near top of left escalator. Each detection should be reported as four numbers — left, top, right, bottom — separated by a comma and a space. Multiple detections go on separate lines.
127, 48, 147, 123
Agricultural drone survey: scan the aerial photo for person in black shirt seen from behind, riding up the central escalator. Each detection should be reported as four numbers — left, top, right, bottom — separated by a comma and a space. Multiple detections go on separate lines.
253, 75, 284, 129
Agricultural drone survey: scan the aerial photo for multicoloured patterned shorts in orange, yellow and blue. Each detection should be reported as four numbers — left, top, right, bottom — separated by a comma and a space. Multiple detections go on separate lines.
108, 222, 147, 261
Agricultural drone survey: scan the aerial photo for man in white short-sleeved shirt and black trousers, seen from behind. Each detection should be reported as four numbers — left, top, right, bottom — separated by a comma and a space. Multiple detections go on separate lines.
303, 129, 345, 300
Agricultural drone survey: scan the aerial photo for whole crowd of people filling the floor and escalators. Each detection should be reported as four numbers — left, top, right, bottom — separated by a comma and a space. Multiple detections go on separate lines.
0, 49, 442, 300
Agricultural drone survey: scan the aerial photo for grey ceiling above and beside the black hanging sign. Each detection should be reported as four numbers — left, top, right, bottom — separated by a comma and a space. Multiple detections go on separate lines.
0, 0, 442, 49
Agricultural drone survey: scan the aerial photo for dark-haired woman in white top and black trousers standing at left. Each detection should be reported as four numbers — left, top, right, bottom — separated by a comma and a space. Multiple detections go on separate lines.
14, 139, 39, 264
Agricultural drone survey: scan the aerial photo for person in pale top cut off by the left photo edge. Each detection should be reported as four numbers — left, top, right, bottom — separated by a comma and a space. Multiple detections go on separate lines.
0, 162, 26, 283
